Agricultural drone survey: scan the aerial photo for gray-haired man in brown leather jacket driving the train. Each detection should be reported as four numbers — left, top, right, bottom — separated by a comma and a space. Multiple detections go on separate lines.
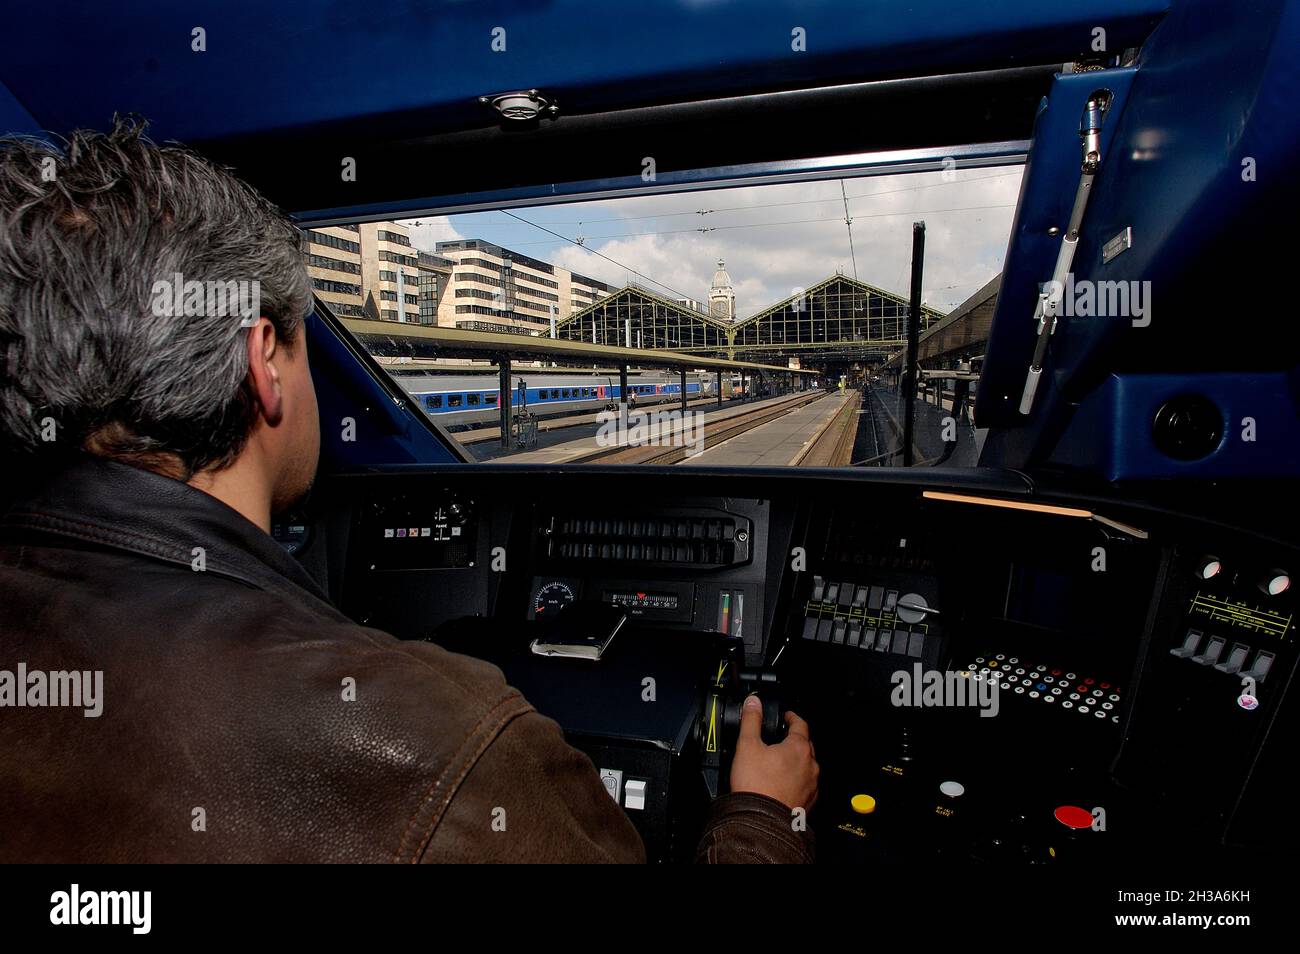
0, 120, 816, 862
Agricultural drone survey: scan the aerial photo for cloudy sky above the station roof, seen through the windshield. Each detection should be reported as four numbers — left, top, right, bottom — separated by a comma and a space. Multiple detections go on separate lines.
406, 166, 1022, 318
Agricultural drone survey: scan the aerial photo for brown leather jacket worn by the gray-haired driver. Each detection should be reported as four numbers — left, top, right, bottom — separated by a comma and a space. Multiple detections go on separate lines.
0, 460, 811, 862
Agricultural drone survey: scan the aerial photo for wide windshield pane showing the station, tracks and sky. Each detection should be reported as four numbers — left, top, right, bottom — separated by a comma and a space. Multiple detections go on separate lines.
361, 171, 1023, 467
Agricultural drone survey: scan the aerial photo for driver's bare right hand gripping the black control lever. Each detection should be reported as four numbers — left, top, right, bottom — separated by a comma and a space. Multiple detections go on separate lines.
731, 695, 820, 810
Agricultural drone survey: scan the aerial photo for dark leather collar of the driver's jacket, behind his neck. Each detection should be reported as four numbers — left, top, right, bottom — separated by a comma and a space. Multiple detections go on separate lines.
0, 458, 333, 610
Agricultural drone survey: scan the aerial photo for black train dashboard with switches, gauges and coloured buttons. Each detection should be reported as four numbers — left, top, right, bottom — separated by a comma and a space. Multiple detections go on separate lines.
295, 465, 1300, 864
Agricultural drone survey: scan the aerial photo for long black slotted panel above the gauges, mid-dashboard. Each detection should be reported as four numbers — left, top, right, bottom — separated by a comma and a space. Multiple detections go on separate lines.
541, 511, 753, 568
